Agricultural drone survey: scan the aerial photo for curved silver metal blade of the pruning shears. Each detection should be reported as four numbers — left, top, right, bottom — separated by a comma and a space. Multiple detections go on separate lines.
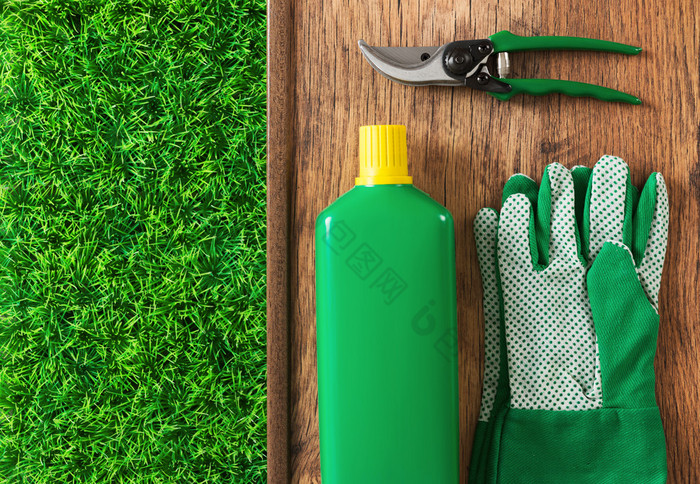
358, 40, 462, 86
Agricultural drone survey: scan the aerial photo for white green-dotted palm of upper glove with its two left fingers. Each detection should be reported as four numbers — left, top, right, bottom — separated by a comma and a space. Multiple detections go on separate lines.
498, 164, 602, 410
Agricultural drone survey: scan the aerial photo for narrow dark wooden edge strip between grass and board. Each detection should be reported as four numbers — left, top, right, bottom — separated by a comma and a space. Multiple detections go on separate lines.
267, 0, 295, 484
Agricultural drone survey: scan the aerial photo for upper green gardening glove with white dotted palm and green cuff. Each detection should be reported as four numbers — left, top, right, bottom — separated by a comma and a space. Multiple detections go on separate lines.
475, 157, 668, 483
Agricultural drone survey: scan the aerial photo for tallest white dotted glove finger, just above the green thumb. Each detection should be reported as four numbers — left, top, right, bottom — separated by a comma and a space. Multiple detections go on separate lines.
583, 155, 629, 261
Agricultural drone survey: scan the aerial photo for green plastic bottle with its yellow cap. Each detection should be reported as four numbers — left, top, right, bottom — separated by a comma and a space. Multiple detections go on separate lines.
316, 126, 459, 484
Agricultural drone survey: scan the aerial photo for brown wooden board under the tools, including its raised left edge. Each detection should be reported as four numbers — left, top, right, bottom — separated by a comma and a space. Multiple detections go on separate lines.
268, 0, 700, 483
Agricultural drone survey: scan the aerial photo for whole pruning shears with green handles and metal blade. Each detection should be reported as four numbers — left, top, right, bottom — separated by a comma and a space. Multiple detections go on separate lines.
359, 30, 642, 104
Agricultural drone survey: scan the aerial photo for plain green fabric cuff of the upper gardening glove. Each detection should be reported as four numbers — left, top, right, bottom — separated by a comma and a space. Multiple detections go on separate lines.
497, 407, 667, 484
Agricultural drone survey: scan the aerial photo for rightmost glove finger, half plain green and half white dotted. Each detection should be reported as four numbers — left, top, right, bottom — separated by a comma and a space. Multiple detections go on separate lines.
633, 173, 668, 308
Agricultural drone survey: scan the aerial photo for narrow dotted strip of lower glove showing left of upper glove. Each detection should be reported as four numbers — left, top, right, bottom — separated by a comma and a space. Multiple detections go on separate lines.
474, 208, 500, 421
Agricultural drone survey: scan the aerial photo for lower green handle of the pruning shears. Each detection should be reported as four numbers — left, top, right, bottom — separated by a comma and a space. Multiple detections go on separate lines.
489, 79, 642, 104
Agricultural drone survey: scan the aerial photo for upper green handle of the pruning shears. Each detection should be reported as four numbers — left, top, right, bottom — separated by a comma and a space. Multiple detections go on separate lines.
489, 30, 642, 55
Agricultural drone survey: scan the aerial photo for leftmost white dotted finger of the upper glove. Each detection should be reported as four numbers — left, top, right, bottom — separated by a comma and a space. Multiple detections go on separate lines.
498, 193, 537, 274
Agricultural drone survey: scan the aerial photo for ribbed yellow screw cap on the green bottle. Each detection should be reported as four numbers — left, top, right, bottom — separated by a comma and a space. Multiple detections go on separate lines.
355, 125, 413, 185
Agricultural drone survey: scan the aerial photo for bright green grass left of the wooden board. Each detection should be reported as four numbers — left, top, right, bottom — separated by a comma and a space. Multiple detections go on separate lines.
0, 0, 266, 483
